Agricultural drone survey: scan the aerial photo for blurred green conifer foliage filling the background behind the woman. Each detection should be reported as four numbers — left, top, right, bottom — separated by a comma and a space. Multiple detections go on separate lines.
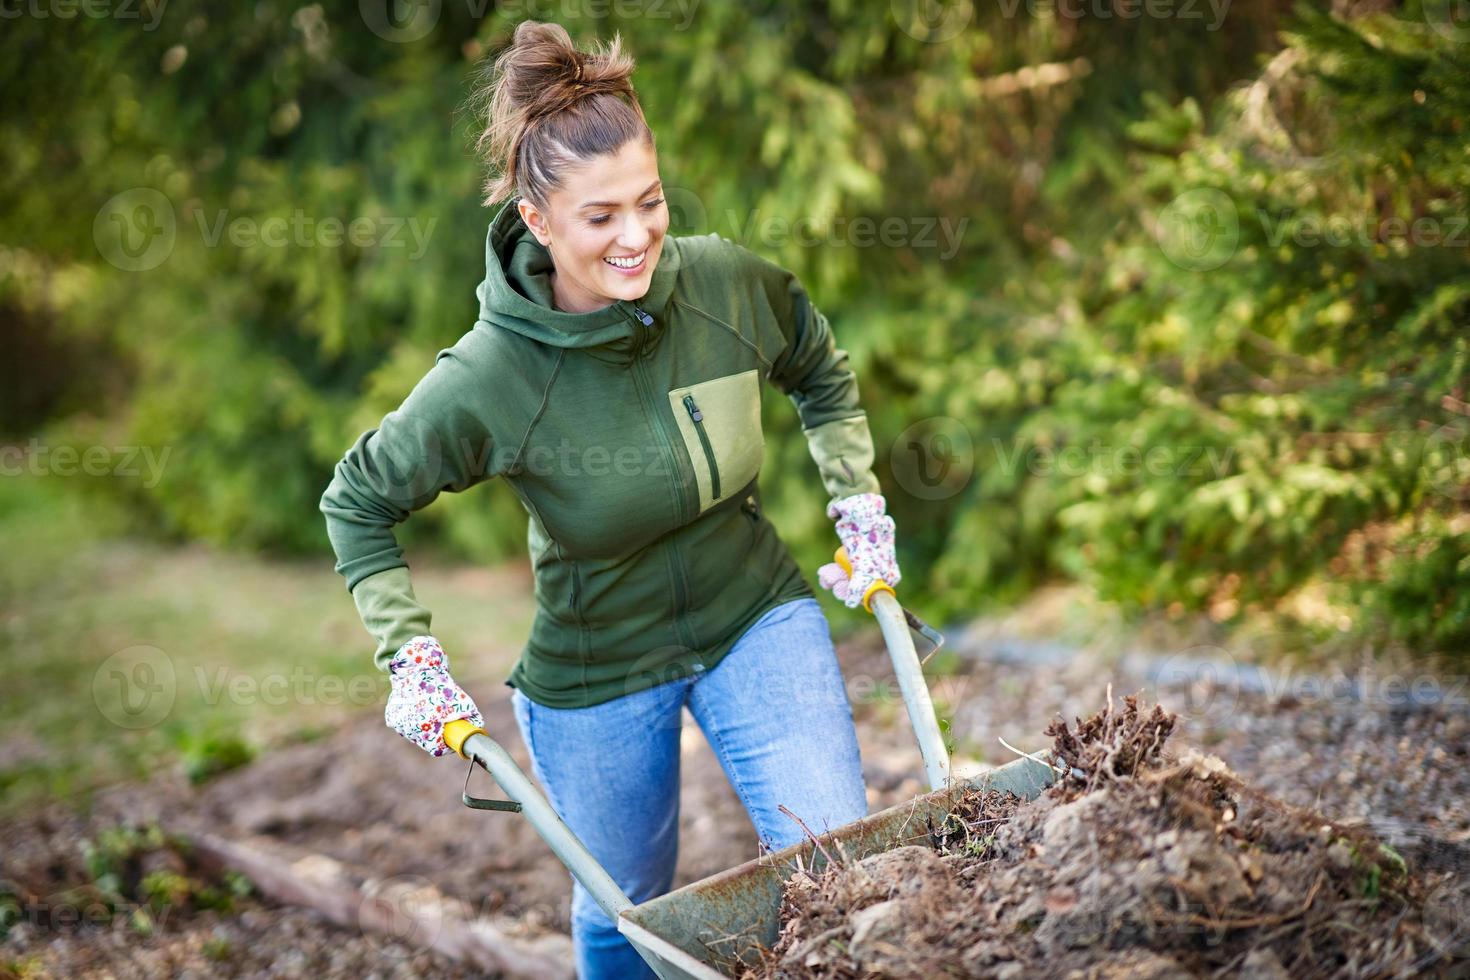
0, 0, 1470, 652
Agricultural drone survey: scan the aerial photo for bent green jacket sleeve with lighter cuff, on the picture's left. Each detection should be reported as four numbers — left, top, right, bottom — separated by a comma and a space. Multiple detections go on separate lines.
319, 348, 494, 671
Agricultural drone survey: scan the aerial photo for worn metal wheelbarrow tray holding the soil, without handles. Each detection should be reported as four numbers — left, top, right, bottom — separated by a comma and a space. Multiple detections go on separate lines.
617, 758, 1055, 980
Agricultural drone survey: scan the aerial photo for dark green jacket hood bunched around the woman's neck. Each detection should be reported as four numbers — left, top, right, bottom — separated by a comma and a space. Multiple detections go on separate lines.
475, 197, 679, 353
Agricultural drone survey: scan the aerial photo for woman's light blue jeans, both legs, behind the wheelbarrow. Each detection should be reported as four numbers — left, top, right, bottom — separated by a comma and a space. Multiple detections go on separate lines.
512, 597, 867, 980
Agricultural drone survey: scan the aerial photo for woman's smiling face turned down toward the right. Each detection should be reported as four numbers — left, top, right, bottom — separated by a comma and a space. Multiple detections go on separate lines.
519, 140, 669, 313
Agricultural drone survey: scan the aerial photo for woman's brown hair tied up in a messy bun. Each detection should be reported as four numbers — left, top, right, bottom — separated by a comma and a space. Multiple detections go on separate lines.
470, 21, 654, 209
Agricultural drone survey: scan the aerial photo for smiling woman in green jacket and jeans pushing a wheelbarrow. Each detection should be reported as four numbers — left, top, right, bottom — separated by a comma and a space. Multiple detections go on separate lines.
322, 21, 900, 977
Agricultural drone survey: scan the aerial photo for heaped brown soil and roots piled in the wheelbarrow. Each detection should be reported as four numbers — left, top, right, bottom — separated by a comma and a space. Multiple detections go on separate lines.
745, 693, 1467, 980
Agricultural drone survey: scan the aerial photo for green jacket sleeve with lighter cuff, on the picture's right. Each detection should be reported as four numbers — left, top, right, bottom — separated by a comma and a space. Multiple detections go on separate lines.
738, 245, 882, 511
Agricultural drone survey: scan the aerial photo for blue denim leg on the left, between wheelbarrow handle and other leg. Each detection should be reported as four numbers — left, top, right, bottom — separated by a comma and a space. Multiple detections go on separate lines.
512, 680, 688, 980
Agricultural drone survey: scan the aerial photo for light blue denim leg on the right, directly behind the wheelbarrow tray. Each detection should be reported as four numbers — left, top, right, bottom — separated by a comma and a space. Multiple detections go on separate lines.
689, 597, 867, 851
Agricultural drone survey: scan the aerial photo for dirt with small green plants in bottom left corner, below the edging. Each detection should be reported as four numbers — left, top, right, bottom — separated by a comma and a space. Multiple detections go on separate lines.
0, 808, 481, 980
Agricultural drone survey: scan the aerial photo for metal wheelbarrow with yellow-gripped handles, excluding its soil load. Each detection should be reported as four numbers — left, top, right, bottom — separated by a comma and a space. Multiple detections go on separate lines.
444, 550, 1055, 980
